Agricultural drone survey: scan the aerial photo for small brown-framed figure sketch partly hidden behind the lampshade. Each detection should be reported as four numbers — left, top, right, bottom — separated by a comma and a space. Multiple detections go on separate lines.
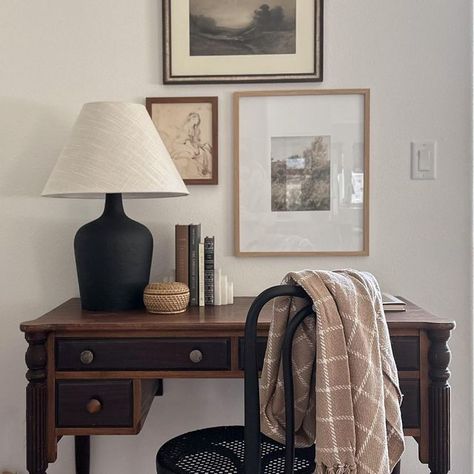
146, 97, 218, 184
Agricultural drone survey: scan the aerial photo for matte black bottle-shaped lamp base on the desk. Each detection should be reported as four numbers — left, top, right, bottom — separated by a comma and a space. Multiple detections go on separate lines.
74, 194, 153, 311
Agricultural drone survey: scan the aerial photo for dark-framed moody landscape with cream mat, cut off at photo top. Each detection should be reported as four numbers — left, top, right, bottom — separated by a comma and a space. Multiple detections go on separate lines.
163, 0, 323, 84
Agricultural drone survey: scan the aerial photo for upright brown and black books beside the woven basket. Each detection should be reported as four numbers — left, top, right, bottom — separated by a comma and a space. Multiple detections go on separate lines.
175, 224, 215, 306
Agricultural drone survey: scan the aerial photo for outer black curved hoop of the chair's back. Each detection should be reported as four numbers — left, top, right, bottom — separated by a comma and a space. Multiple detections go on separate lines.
244, 285, 313, 474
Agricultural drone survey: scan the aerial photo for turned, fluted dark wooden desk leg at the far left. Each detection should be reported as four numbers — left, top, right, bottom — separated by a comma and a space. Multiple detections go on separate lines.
25, 333, 48, 474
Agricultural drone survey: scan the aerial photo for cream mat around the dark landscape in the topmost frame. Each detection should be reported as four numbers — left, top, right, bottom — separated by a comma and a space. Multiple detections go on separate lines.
170, 0, 320, 76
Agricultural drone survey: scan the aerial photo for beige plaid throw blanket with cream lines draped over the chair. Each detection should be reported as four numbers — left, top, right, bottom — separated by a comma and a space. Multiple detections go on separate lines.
261, 270, 404, 474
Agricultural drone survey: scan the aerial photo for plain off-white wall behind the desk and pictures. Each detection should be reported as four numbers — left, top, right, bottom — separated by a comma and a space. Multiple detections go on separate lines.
0, 0, 472, 474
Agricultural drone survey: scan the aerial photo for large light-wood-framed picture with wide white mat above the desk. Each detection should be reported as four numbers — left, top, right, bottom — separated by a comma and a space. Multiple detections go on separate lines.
234, 89, 370, 256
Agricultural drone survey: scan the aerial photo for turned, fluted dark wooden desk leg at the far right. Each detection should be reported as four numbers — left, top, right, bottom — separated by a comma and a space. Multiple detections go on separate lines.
428, 330, 451, 474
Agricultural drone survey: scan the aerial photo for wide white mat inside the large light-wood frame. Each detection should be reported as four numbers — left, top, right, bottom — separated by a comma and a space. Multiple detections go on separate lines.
239, 94, 364, 253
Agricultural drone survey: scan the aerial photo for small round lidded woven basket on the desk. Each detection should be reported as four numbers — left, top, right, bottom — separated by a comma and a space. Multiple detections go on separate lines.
143, 282, 189, 314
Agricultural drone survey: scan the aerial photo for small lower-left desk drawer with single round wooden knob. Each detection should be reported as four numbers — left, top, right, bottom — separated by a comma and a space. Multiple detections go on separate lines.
56, 380, 133, 428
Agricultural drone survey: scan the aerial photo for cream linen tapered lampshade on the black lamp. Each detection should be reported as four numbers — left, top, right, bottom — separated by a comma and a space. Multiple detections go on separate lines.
42, 102, 189, 198
